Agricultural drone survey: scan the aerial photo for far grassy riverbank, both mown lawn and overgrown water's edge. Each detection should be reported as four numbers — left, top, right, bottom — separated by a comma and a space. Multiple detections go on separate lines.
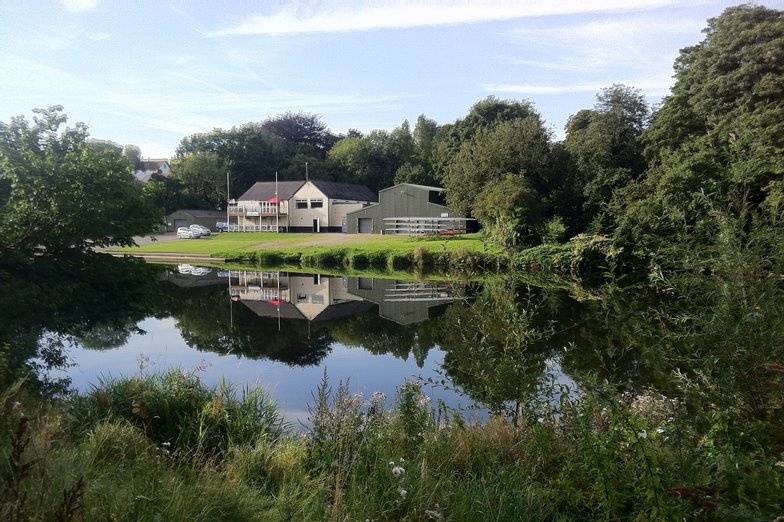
108, 232, 617, 279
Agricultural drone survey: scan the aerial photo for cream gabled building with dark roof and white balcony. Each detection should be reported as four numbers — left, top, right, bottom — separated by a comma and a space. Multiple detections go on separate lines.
229, 181, 378, 232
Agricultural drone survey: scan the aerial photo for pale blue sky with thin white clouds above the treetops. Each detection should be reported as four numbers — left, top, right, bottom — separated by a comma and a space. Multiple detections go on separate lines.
0, 0, 784, 157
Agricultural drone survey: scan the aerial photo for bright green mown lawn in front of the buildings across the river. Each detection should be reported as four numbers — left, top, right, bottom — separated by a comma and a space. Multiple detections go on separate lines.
117, 232, 491, 258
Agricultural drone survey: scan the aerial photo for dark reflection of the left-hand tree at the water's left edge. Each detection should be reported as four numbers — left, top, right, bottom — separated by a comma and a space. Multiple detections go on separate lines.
0, 255, 166, 392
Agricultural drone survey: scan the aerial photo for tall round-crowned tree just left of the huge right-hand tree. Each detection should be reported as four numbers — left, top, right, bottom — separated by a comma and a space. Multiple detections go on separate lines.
564, 84, 650, 230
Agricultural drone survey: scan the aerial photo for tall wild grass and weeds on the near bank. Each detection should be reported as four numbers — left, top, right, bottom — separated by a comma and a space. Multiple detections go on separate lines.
0, 371, 784, 521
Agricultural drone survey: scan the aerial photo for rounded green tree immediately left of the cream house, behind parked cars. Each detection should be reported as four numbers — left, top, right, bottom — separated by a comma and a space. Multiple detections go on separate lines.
171, 152, 229, 209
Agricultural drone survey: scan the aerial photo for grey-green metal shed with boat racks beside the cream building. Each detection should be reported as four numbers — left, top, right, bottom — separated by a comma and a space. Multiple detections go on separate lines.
346, 183, 470, 234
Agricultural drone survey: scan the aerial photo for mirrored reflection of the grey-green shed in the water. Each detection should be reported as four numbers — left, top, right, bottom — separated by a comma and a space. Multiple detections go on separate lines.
348, 277, 465, 325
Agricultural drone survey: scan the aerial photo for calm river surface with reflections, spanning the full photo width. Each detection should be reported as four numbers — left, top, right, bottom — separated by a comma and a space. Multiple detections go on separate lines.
0, 256, 784, 428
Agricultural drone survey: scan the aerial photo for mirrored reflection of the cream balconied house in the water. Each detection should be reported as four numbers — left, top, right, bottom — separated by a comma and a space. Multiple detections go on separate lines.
229, 270, 372, 321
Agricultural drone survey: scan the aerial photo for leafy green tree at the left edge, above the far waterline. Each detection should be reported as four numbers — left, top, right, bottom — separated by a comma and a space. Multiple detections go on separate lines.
0, 106, 161, 258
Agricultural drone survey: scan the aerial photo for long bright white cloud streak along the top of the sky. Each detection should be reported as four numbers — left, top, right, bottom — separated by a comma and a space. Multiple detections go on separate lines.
207, 0, 684, 36
